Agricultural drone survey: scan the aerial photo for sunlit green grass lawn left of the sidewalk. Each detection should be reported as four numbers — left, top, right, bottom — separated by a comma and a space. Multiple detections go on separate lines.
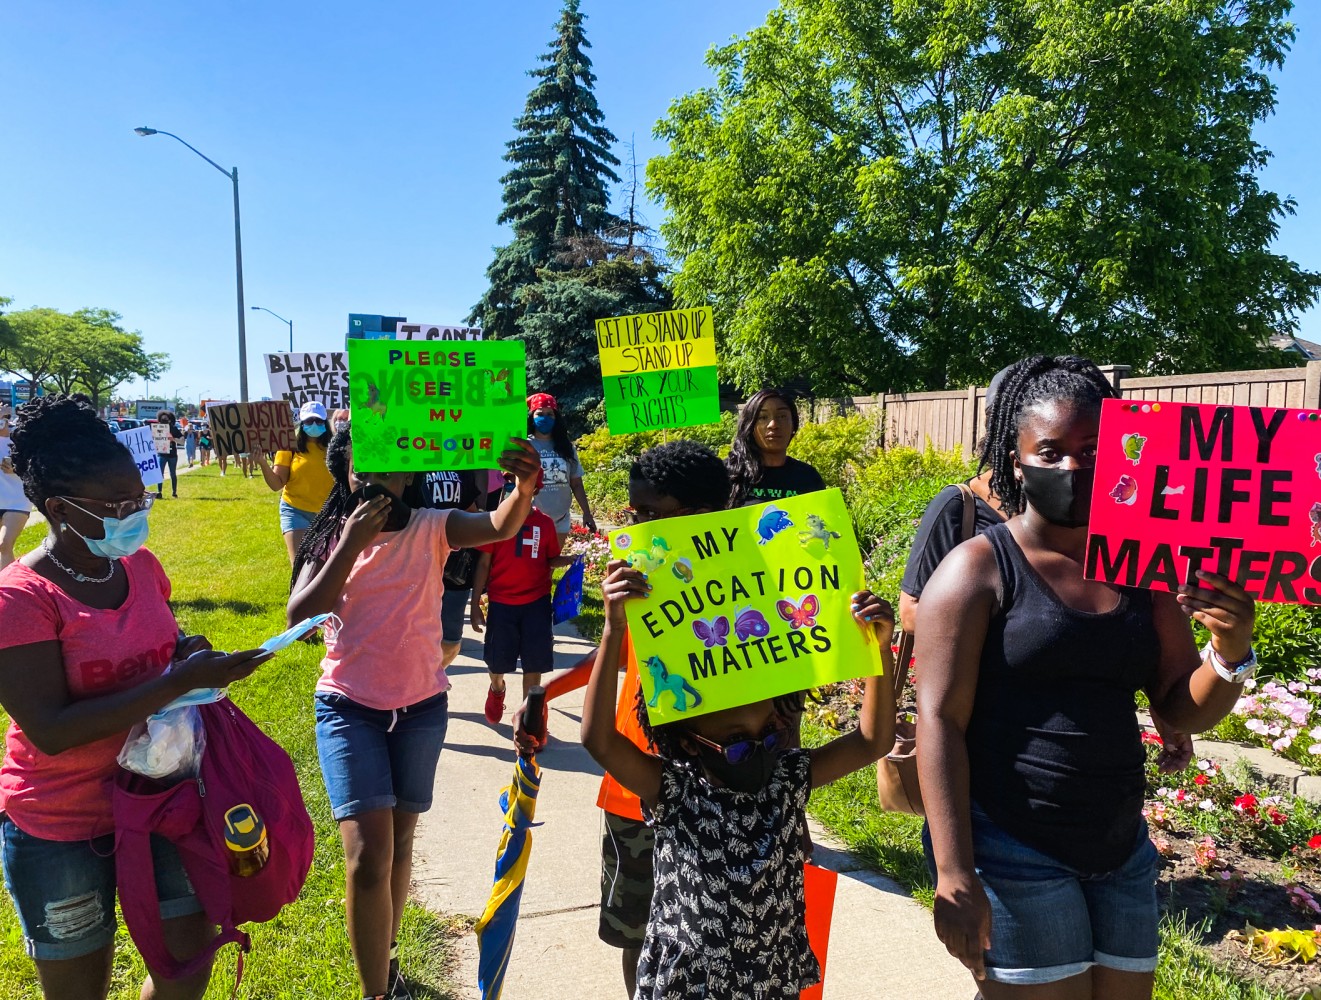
0, 466, 460, 1000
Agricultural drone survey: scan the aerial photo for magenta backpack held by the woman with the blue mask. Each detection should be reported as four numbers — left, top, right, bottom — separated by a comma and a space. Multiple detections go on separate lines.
114, 699, 314, 980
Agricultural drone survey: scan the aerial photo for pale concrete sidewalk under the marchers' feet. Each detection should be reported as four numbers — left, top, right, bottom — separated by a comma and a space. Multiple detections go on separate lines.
413, 629, 975, 1000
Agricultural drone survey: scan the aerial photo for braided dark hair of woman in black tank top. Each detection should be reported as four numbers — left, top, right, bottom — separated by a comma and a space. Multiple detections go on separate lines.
978, 354, 1118, 515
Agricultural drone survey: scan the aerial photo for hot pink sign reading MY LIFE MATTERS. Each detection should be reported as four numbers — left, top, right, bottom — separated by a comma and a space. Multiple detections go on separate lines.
1086, 399, 1321, 604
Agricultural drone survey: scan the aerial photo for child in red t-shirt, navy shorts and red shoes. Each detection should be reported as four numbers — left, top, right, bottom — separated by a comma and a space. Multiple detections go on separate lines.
472, 472, 573, 725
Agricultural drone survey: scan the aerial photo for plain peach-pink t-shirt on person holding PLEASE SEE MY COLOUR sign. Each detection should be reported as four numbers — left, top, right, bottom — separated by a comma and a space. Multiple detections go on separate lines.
317, 510, 450, 711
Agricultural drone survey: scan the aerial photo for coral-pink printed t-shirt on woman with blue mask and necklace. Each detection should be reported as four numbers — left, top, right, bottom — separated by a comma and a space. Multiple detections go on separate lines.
0, 548, 178, 840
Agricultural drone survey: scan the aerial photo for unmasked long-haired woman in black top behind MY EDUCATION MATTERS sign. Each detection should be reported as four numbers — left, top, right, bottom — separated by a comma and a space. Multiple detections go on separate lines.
727, 388, 826, 509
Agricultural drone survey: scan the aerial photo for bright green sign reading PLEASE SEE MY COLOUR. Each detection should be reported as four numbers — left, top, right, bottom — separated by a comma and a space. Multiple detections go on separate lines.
349, 341, 527, 472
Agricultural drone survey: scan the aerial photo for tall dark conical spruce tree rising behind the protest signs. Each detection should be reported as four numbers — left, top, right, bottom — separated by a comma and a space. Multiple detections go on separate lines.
469, 0, 620, 337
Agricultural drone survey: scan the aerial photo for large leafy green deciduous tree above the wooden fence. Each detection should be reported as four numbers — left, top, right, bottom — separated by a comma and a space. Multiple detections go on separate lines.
647, 0, 1321, 392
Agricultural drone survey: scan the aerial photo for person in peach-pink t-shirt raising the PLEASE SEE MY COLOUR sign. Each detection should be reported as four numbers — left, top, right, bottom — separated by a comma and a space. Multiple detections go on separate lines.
288, 428, 542, 997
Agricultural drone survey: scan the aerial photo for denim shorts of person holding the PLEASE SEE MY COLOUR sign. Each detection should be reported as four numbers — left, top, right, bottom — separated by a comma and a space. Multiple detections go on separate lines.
316, 691, 449, 820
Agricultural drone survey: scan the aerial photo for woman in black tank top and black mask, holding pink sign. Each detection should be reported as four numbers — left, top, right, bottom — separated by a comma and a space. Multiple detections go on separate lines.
915, 355, 1252, 1000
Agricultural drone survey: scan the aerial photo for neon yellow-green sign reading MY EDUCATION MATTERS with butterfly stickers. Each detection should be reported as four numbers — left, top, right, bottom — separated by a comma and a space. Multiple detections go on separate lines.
610, 490, 881, 723
